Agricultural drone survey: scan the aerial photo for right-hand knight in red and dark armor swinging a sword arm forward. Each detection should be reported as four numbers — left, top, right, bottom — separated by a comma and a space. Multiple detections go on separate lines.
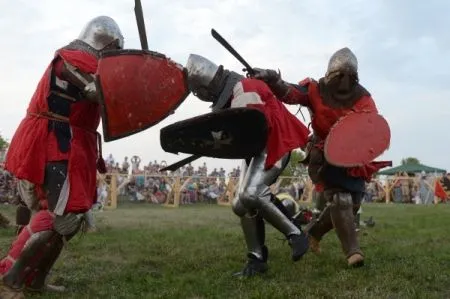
255, 48, 390, 267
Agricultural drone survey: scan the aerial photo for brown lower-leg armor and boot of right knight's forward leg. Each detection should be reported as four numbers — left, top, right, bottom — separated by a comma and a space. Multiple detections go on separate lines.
330, 192, 364, 267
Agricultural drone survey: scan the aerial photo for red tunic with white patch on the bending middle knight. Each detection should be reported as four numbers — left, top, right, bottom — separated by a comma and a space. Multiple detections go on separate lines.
231, 78, 310, 169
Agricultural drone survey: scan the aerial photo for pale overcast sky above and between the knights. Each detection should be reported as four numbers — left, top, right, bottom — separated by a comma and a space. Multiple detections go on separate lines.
0, 0, 450, 170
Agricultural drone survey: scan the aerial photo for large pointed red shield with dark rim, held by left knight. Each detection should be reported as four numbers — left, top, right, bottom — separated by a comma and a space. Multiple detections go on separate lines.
97, 50, 189, 141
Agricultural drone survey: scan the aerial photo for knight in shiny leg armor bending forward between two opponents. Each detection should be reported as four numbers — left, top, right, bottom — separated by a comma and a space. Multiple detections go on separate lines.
186, 55, 309, 276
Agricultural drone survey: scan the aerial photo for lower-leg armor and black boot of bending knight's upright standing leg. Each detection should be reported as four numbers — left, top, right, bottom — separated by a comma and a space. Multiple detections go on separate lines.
234, 214, 269, 277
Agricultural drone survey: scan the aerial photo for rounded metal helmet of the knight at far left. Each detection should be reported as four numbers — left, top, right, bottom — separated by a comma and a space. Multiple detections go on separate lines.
78, 16, 124, 51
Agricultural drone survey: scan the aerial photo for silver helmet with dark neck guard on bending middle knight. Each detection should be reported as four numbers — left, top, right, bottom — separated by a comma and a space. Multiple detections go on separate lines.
186, 54, 244, 111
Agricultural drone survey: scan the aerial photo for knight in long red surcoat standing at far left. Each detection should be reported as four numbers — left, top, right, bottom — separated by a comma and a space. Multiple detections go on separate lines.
0, 16, 124, 298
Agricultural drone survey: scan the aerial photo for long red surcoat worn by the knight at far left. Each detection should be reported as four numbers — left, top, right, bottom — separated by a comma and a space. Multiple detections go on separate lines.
5, 49, 100, 213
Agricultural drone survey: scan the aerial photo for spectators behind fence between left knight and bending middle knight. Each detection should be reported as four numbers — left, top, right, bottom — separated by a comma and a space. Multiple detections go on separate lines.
103, 155, 240, 204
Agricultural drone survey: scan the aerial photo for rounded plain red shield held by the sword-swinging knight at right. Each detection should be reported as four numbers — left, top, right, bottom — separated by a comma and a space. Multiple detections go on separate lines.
324, 112, 391, 167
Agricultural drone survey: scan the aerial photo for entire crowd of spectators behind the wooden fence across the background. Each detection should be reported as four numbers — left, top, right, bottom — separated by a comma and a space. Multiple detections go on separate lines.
0, 155, 450, 209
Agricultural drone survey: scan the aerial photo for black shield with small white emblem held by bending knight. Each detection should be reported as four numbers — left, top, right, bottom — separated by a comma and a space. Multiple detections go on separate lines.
160, 108, 268, 159
